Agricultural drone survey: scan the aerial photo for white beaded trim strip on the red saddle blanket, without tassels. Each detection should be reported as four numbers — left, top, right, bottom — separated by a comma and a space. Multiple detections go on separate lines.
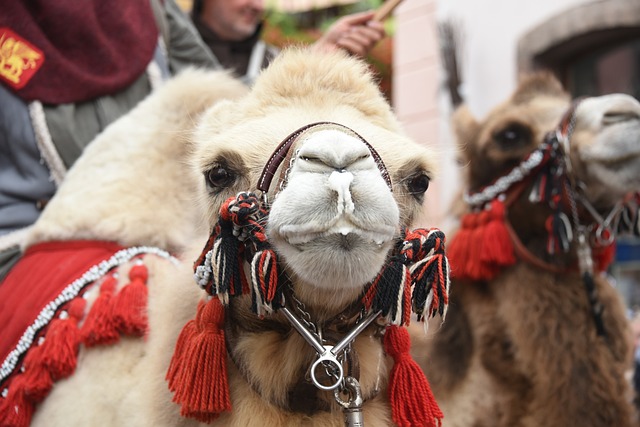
0, 246, 179, 383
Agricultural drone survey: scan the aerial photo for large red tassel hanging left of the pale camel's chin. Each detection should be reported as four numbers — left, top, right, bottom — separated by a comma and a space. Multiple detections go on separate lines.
167, 297, 231, 422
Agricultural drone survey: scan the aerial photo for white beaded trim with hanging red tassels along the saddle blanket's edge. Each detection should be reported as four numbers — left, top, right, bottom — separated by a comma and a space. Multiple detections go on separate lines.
0, 243, 178, 426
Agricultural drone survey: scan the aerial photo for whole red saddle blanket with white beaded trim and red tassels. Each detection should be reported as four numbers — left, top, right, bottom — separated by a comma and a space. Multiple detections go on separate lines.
0, 241, 165, 426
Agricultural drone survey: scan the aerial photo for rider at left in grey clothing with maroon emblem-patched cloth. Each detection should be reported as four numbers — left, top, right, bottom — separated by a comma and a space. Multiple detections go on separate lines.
0, 0, 220, 281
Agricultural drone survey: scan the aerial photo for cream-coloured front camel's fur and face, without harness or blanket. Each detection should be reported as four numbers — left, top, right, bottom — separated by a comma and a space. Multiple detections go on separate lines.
2, 49, 444, 427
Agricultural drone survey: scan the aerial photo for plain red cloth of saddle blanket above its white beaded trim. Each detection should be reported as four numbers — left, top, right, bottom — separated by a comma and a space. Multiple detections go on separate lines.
0, 240, 123, 362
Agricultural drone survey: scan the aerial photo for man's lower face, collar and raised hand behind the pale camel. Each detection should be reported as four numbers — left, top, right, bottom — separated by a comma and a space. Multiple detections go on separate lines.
191, 0, 385, 84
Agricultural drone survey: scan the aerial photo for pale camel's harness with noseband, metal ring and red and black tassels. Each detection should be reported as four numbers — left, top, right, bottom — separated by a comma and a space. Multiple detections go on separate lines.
167, 122, 449, 426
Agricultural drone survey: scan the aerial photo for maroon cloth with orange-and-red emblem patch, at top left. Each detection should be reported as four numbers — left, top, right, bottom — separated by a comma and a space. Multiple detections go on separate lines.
0, 0, 158, 104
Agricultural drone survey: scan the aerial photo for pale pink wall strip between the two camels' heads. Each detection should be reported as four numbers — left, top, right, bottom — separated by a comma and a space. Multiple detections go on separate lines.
393, 0, 459, 232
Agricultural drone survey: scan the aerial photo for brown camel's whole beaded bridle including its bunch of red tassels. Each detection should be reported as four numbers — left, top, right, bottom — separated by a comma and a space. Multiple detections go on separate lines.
448, 100, 640, 336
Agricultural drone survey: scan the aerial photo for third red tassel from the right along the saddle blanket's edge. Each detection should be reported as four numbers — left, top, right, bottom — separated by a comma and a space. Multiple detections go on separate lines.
42, 297, 87, 381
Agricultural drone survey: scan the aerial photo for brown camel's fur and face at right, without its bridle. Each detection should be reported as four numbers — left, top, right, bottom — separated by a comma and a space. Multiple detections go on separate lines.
413, 73, 640, 427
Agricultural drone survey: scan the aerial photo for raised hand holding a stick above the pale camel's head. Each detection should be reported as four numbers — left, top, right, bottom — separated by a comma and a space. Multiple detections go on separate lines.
313, 11, 385, 57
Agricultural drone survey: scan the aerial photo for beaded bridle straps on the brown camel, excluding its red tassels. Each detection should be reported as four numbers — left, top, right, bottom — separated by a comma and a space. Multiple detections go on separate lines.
452, 99, 640, 335
